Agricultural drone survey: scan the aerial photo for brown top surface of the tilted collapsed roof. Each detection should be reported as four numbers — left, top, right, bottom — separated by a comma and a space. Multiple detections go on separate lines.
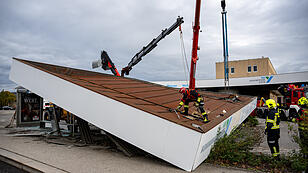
15, 58, 253, 133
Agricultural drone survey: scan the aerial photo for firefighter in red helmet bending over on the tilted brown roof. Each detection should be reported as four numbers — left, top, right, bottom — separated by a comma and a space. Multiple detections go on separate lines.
176, 87, 209, 122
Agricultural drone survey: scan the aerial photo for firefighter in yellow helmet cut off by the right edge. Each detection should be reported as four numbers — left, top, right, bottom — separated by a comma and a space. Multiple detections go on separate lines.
292, 97, 308, 158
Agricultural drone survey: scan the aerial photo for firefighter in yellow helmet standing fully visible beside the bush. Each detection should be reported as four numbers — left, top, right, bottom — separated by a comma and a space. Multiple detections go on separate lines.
265, 99, 280, 158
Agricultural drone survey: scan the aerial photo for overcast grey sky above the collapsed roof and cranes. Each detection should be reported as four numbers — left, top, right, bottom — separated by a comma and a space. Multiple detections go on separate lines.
0, 0, 308, 90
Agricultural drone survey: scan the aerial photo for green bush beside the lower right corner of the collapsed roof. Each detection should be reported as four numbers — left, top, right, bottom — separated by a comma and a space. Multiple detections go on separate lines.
206, 117, 308, 172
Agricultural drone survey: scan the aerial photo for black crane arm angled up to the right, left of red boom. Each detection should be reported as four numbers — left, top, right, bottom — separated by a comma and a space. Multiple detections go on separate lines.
121, 16, 184, 76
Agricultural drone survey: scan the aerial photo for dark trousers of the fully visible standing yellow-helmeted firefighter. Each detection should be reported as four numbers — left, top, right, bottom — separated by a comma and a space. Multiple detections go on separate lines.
267, 129, 280, 157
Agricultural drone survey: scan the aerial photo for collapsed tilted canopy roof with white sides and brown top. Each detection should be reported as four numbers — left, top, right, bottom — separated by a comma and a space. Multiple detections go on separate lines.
10, 58, 256, 171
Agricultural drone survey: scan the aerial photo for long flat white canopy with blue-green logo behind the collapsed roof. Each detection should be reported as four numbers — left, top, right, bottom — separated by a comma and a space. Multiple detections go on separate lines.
155, 71, 308, 99
